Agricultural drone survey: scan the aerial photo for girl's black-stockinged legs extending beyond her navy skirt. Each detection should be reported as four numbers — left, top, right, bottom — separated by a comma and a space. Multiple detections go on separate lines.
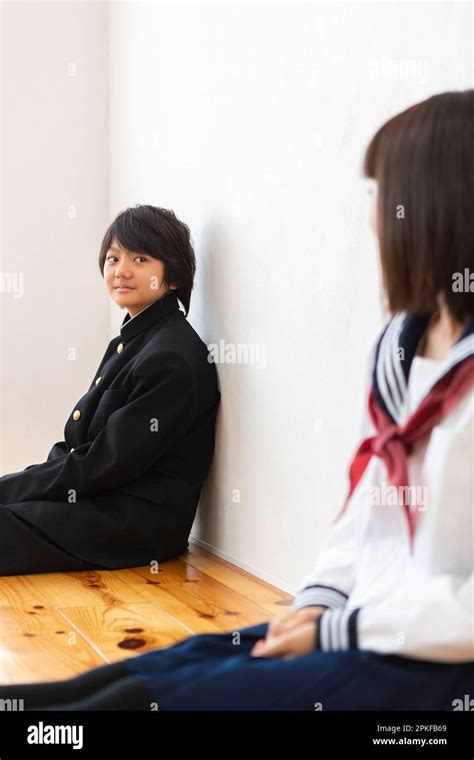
0, 662, 153, 711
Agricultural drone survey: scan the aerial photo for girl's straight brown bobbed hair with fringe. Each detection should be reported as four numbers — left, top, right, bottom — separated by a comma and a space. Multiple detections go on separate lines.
363, 90, 474, 322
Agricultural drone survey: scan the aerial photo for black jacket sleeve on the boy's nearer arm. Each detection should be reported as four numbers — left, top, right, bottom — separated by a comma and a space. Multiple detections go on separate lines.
0, 351, 196, 504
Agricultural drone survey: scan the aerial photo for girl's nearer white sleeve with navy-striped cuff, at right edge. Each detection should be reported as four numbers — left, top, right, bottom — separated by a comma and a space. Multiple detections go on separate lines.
317, 393, 474, 662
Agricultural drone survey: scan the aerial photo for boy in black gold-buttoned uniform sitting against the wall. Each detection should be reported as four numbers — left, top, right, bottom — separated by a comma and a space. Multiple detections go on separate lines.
0, 206, 220, 575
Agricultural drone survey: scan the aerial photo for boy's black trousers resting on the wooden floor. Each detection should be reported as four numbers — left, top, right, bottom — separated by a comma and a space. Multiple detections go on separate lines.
0, 498, 182, 576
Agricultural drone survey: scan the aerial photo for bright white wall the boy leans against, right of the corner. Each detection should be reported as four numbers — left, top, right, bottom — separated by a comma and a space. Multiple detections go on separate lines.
110, 2, 472, 590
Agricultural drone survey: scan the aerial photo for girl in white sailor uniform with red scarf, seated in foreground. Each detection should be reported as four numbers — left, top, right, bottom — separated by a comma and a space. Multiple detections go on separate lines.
0, 90, 474, 710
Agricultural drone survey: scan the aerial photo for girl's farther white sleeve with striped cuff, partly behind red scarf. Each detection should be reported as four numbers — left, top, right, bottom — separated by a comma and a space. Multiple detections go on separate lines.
293, 349, 375, 614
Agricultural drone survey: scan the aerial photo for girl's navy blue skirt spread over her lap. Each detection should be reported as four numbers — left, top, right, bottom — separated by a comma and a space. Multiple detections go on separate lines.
125, 623, 474, 711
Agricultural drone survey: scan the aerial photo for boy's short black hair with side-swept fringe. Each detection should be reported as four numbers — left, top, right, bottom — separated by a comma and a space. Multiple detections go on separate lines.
99, 204, 196, 314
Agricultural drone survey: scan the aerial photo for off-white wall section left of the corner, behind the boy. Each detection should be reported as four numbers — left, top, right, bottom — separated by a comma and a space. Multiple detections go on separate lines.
0, 2, 109, 473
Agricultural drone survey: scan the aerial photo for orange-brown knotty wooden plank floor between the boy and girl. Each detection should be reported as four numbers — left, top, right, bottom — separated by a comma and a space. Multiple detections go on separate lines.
0, 544, 292, 684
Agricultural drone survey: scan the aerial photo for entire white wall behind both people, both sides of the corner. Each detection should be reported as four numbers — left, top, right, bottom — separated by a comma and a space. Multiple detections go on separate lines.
1, 2, 472, 591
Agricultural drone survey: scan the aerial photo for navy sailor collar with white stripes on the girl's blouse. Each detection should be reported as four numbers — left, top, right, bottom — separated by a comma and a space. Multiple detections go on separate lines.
372, 312, 474, 425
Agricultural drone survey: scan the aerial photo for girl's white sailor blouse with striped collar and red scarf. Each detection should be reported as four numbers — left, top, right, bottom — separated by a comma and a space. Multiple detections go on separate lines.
293, 314, 474, 662
